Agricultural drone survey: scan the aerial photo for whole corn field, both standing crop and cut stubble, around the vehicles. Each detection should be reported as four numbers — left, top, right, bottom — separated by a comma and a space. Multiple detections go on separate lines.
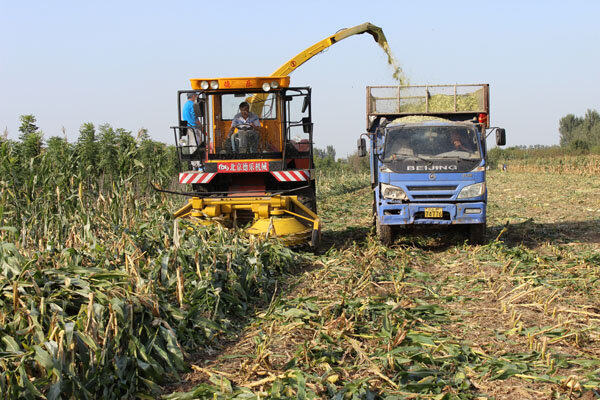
0, 126, 600, 400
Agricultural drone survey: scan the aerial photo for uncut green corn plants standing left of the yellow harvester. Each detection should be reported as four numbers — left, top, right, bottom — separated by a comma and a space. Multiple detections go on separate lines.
0, 118, 296, 399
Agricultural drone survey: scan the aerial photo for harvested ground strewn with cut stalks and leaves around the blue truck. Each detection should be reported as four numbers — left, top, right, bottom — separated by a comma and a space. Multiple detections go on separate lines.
164, 170, 600, 399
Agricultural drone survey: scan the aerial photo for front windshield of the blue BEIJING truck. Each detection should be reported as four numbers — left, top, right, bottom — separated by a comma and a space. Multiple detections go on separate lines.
383, 125, 481, 162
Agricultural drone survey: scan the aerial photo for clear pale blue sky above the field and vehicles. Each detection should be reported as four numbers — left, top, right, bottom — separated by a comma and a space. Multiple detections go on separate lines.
0, 0, 600, 156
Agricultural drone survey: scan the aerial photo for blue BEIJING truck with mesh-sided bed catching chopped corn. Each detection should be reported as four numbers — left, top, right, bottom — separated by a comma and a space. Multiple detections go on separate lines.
358, 84, 506, 244
